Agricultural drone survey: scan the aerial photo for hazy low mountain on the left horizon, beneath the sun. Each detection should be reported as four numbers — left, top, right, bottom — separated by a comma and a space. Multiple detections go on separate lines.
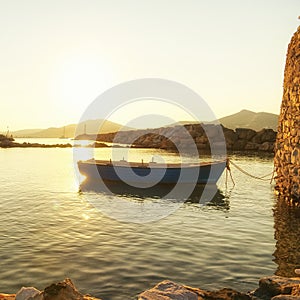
12, 120, 134, 138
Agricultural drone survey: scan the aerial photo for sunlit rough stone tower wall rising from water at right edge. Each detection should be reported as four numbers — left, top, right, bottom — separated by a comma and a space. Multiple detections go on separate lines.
274, 27, 300, 202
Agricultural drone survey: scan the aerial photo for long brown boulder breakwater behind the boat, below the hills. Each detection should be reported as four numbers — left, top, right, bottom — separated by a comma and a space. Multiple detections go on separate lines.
97, 124, 276, 153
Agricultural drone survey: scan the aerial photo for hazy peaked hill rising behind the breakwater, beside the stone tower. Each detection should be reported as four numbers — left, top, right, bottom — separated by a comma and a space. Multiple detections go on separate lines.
219, 109, 278, 131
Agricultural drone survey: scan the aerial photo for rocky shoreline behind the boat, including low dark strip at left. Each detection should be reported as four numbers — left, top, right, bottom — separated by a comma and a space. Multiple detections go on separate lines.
0, 123, 277, 155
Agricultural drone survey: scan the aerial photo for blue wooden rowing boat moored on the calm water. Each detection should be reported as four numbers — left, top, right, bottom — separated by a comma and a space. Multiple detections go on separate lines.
78, 159, 226, 186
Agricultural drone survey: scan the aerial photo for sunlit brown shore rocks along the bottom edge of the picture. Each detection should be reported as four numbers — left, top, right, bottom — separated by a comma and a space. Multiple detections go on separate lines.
0, 276, 300, 300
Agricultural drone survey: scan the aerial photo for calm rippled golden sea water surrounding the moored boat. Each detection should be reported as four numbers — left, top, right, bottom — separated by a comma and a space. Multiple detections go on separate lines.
0, 140, 300, 300
